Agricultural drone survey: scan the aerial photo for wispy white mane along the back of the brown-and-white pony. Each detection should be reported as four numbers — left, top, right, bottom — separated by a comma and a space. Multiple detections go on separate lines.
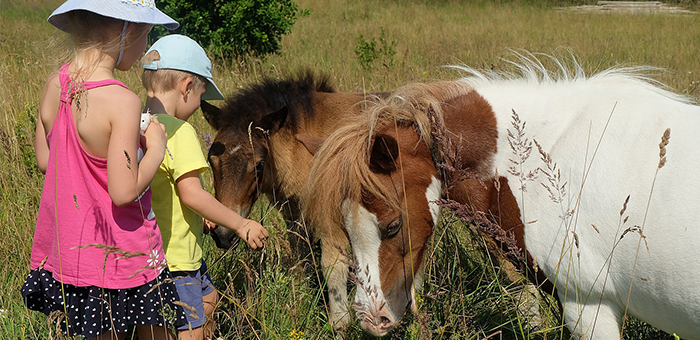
446, 51, 695, 104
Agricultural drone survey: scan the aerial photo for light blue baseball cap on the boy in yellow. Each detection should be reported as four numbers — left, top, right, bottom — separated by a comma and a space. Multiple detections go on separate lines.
141, 34, 224, 100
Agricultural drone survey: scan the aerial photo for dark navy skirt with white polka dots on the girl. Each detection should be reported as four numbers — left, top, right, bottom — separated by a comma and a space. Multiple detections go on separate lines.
22, 268, 187, 337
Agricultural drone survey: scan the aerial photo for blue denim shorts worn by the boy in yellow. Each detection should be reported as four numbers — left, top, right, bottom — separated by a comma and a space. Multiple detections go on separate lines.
171, 260, 214, 330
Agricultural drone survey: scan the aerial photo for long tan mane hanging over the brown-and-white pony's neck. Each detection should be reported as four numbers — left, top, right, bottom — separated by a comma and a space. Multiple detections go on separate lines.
302, 81, 472, 230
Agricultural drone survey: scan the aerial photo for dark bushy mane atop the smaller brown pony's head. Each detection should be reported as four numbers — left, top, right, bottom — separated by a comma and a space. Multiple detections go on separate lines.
219, 70, 336, 129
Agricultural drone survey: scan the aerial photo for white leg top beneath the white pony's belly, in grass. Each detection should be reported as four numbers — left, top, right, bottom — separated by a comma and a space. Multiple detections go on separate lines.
564, 299, 622, 340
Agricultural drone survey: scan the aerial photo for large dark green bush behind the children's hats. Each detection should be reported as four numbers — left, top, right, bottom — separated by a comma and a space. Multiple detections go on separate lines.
151, 0, 308, 59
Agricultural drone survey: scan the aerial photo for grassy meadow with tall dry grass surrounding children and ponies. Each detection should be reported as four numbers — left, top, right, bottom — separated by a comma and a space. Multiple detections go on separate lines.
0, 0, 700, 340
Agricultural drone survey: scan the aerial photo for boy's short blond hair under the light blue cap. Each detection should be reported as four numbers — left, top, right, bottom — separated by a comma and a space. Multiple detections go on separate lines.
141, 51, 207, 92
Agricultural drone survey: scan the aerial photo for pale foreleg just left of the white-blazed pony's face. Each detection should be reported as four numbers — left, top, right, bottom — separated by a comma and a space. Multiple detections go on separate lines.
321, 230, 351, 329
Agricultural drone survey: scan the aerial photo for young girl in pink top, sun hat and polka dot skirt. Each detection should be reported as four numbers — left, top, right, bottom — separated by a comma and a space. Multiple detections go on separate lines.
22, 0, 184, 339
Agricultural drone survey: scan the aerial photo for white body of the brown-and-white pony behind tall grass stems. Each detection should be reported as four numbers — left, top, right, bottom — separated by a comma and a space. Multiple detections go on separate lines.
460, 64, 700, 339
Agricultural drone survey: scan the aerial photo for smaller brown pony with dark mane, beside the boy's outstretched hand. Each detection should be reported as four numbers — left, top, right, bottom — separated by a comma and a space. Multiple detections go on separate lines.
202, 71, 382, 328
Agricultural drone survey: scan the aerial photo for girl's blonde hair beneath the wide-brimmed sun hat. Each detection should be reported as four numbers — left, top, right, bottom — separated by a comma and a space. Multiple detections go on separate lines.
60, 10, 153, 80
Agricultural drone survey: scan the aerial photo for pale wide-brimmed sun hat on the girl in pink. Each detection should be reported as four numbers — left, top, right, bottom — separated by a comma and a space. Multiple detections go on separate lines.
48, 0, 180, 32
